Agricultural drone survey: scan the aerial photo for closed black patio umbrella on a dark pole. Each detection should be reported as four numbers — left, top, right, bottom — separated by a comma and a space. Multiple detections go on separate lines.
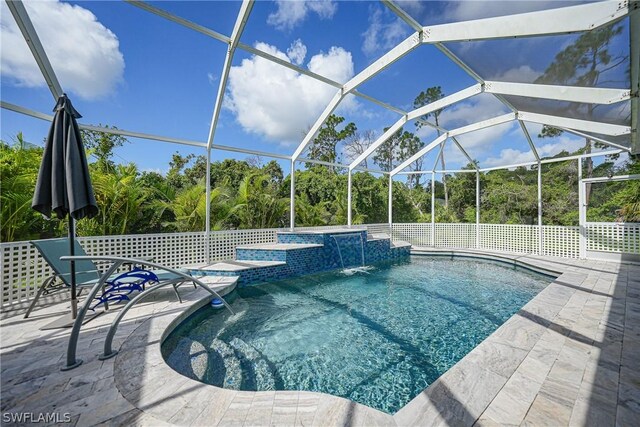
31, 94, 98, 319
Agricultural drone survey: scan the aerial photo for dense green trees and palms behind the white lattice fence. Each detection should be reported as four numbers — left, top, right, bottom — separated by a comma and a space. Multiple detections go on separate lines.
0, 117, 640, 241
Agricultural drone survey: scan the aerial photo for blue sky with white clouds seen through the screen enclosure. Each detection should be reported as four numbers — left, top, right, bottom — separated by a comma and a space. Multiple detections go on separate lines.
0, 1, 628, 177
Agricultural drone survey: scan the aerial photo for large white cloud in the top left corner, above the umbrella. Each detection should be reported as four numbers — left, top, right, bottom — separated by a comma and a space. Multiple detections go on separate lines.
0, 1, 125, 99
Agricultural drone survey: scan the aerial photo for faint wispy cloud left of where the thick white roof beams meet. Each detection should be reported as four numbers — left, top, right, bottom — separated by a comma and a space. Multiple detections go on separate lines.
362, 7, 408, 55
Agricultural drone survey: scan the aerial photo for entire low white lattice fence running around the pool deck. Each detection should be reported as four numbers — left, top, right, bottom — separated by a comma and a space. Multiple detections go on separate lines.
0, 223, 640, 307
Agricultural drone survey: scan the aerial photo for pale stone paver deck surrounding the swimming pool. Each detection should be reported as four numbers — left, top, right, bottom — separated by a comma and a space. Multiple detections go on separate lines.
0, 251, 640, 426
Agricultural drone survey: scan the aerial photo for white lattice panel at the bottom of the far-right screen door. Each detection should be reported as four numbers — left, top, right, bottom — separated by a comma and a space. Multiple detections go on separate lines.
587, 223, 640, 254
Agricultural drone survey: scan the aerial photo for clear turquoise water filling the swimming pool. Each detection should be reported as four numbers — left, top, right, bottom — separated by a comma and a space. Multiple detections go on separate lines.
162, 256, 552, 413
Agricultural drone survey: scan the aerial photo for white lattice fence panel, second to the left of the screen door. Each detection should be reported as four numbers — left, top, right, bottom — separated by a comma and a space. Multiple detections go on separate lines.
480, 224, 539, 254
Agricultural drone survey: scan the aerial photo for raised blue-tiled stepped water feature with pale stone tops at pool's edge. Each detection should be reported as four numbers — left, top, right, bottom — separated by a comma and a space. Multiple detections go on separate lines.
187, 229, 411, 285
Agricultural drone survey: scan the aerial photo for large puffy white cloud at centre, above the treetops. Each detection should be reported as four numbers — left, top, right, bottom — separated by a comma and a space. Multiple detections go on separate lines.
225, 41, 354, 144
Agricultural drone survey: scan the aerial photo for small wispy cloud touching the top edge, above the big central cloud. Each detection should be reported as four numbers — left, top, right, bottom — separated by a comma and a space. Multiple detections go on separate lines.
267, 0, 338, 31
